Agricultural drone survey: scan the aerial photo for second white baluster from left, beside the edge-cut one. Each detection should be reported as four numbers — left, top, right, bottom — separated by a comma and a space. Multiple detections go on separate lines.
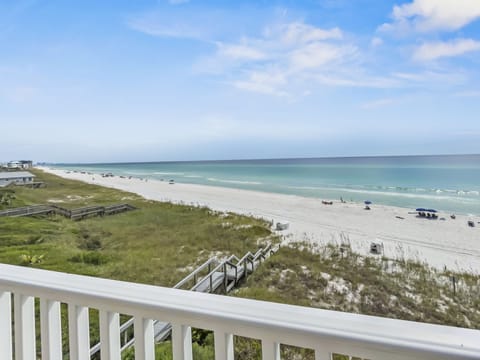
14, 294, 36, 360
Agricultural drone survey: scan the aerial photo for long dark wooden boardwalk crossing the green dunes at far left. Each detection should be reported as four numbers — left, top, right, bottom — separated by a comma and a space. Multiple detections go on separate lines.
0, 204, 136, 220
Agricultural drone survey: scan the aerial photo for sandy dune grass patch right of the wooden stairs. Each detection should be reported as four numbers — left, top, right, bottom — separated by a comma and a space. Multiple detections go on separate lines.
234, 244, 480, 329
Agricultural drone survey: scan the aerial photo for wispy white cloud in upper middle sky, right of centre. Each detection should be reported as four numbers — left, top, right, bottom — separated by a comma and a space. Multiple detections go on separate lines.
196, 21, 357, 96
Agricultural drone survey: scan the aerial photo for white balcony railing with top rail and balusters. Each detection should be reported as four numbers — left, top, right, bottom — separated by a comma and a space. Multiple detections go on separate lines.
0, 264, 480, 360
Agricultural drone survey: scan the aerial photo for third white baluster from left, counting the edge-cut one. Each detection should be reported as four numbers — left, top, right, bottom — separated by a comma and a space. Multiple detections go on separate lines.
40, 299, 62, 360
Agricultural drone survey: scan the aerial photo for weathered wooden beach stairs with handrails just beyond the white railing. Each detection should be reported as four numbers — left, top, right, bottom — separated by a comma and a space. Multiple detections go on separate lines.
90, 244, 280, 357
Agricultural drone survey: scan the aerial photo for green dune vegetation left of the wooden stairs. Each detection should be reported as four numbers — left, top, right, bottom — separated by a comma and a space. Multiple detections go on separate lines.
0, 171, 274, 286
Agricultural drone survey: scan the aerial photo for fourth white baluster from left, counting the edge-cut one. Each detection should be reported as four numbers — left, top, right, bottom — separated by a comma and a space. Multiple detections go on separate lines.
68, 304, 90, 360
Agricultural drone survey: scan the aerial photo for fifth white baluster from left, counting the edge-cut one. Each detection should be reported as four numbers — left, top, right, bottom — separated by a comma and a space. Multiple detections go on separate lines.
99, 310, 121, 360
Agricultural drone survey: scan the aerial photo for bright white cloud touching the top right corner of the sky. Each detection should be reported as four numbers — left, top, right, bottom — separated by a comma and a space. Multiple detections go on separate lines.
380, 0, 480, 32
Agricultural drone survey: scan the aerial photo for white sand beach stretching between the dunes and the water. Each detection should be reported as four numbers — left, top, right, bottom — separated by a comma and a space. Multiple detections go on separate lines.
40, 167, 480, 273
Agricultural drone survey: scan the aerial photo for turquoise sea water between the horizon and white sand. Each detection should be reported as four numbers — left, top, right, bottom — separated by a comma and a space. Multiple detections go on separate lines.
53, 155, 480, 215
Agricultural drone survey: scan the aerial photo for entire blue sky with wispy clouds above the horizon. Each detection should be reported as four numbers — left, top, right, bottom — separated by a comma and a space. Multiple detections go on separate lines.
0, 0, 480, 163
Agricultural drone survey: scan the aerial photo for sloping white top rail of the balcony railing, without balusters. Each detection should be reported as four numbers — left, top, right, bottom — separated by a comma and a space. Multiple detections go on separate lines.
0, 264, 480, 359
